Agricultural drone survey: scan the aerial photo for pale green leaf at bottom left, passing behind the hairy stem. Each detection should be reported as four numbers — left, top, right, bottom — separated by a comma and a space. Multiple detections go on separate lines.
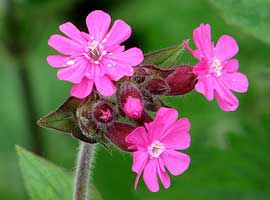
16, 146, 102, 200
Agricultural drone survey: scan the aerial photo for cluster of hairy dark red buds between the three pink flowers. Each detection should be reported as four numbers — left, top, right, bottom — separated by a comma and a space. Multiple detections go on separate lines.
73, 65, 196, 151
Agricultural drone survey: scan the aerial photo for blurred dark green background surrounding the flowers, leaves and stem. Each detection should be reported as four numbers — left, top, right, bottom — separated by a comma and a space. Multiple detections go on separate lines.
0, 0, 270, 200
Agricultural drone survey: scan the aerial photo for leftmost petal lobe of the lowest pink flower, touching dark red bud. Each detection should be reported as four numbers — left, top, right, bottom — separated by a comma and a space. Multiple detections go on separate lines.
125, 126, 149, 148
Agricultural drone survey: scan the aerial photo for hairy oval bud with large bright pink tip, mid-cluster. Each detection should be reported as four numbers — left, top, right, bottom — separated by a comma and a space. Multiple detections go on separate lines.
119, 82, 144, 119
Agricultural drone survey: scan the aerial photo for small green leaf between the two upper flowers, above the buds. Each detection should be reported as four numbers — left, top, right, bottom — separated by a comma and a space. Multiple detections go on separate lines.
142, 45, 184, 67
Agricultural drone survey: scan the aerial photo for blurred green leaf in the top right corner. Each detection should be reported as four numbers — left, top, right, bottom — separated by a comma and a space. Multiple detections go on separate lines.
211, 0, 270, 44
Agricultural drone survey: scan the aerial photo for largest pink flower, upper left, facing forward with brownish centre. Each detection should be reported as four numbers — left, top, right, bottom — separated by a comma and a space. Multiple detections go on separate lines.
47, 10, 143, 98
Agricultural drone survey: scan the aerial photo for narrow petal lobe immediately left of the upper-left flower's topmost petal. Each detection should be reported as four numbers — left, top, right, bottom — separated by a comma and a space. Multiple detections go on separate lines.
59, 22, 87, 45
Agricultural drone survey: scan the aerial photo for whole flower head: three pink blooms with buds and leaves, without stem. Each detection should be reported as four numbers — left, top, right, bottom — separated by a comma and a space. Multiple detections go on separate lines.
43, 10, 248, 192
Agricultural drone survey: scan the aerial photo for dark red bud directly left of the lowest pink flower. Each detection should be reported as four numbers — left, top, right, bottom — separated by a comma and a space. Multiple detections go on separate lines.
106, 122, 136, 151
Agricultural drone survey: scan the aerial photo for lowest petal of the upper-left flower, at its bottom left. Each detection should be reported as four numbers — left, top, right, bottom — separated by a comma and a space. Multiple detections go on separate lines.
70, 78, 93, 99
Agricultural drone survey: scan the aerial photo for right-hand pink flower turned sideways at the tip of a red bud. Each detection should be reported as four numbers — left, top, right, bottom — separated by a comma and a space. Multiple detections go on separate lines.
183, 24, 248, 111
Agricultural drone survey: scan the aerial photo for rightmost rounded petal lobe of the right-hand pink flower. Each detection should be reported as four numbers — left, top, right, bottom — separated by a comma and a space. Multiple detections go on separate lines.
222, 72, 248, 93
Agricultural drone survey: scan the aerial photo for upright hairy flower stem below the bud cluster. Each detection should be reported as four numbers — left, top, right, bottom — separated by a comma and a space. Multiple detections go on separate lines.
73, 142, 94, 200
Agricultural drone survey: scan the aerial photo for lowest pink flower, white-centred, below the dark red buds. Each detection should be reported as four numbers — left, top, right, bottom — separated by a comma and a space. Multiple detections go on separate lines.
126, 108, 190, 192
